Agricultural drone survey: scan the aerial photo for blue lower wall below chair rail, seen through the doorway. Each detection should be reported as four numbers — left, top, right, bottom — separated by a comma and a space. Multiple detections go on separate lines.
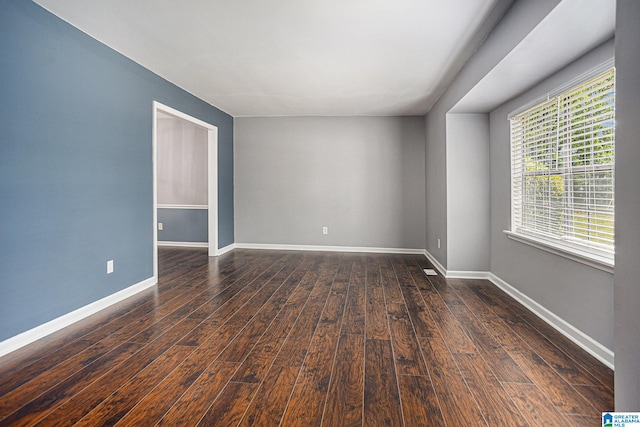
158, 209, 209, 243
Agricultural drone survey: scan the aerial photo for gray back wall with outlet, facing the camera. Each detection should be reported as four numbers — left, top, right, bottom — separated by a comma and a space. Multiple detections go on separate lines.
235, 117, 425, 249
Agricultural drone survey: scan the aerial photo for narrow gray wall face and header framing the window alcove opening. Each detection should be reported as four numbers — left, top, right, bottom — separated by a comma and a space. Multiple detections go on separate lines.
426, 0, 560, 268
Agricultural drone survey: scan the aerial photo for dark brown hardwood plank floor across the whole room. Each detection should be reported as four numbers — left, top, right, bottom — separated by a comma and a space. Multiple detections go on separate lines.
0, 248, 613, 427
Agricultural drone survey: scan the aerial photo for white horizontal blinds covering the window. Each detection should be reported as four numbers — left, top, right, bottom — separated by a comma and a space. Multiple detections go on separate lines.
510, 69, 615, 260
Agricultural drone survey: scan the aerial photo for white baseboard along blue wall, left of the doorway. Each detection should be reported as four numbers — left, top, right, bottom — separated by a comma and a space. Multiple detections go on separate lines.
0, 277, 158, 357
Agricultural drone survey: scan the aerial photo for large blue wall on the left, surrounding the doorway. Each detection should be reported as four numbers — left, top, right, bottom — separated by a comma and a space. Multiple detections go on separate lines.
0, 0, 234, 341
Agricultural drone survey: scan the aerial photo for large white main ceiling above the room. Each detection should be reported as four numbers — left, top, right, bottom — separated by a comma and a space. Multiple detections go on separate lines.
35, 0, 504, 117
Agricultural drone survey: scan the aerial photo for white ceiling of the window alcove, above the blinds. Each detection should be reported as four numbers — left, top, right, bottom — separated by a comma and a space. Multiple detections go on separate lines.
451, 0, 616, 113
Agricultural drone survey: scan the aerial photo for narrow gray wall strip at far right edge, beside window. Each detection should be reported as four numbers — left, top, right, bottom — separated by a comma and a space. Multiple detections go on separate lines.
613, 0, 640, 411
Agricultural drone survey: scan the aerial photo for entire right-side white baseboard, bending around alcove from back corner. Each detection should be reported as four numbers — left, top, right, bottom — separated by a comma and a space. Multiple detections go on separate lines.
424, 250, 614, 369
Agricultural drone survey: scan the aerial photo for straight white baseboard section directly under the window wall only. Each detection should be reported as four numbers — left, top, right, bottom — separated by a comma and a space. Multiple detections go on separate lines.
489, 273, 614, 369
